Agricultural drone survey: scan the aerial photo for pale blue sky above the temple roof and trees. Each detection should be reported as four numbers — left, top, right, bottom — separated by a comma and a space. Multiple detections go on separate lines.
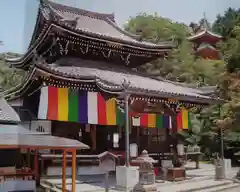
0, 0, 240, 53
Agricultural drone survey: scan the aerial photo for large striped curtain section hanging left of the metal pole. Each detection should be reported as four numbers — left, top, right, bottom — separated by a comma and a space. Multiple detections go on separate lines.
38, 87, 124, 125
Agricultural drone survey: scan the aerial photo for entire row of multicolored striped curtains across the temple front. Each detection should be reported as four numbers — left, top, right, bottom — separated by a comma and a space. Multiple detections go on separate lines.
38, 86, 186, 129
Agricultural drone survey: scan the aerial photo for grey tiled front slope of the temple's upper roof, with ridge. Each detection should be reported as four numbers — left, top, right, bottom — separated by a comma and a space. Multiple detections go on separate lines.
43, 0, 174, 49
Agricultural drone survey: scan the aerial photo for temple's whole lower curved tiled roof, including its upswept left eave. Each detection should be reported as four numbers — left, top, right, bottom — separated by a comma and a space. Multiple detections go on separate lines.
4, 57, 218, 103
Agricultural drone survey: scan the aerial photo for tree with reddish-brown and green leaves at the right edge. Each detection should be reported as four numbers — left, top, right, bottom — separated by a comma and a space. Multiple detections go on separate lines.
217, 24, 240, 132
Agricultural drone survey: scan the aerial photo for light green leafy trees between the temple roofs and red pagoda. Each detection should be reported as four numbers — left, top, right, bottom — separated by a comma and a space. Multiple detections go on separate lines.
125, 14, 224, 85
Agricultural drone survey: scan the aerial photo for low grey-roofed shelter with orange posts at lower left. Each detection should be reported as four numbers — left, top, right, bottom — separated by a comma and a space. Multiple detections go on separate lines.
0, 133, 89, 192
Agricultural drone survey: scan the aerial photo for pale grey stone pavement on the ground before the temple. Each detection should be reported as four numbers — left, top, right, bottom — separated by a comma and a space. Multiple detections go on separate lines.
40, 163, 240, 192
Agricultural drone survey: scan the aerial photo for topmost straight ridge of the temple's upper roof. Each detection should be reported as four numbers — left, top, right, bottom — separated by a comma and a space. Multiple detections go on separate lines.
45, 0, 115, 23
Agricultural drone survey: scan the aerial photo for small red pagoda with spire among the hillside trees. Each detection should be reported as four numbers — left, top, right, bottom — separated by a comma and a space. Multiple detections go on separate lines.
188, 14, 222, 60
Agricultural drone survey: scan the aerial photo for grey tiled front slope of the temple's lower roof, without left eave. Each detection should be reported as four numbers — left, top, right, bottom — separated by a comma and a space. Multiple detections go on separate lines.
35, 59, 218, 103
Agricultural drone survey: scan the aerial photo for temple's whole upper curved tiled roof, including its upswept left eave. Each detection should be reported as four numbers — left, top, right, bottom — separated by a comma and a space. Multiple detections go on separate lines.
6, 0, 174, 67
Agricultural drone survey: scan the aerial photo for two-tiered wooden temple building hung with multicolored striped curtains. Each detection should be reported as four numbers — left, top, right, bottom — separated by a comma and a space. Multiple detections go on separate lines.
4, 0, 218, 177
